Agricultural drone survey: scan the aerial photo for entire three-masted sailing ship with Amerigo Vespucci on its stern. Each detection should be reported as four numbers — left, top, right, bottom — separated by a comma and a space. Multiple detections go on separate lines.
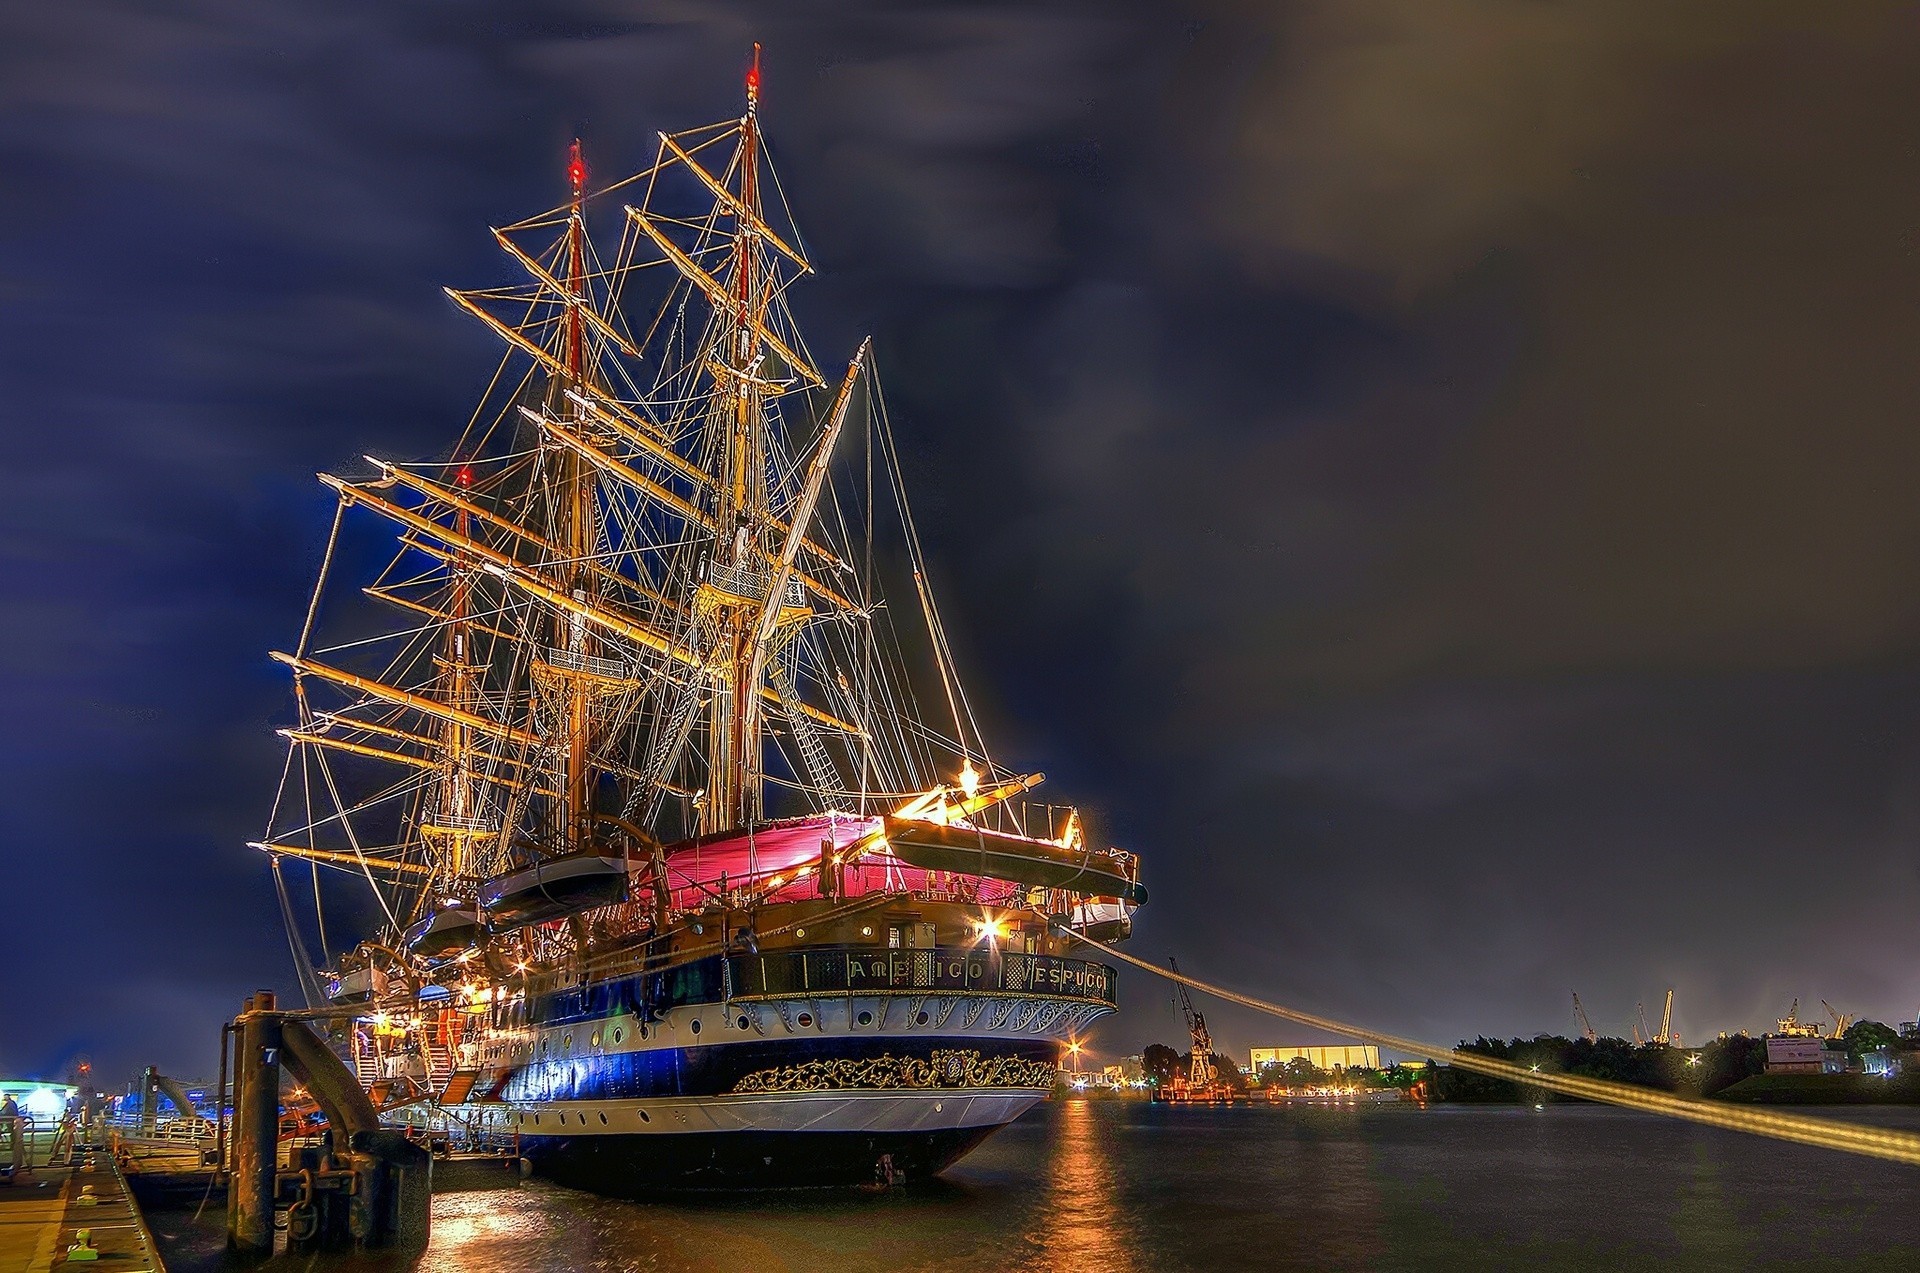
255, 50, 1146, 1192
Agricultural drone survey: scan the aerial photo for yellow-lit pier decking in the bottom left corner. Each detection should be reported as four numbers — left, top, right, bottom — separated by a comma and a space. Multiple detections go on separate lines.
0, 1154, 167, 1273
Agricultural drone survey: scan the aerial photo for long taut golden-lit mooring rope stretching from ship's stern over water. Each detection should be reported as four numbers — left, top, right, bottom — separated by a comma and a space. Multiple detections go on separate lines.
1058, 927, 1920, 1165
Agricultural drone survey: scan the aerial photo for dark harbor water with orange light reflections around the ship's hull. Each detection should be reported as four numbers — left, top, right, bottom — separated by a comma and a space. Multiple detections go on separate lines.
150, 1100, 1920, 1273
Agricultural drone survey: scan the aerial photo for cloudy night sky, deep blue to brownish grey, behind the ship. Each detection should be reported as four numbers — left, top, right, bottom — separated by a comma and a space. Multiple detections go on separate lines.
0, 0, 1920, 1077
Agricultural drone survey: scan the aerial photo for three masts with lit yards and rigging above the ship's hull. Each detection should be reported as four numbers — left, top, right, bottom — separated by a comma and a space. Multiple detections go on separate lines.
263, 59, 936, 960
